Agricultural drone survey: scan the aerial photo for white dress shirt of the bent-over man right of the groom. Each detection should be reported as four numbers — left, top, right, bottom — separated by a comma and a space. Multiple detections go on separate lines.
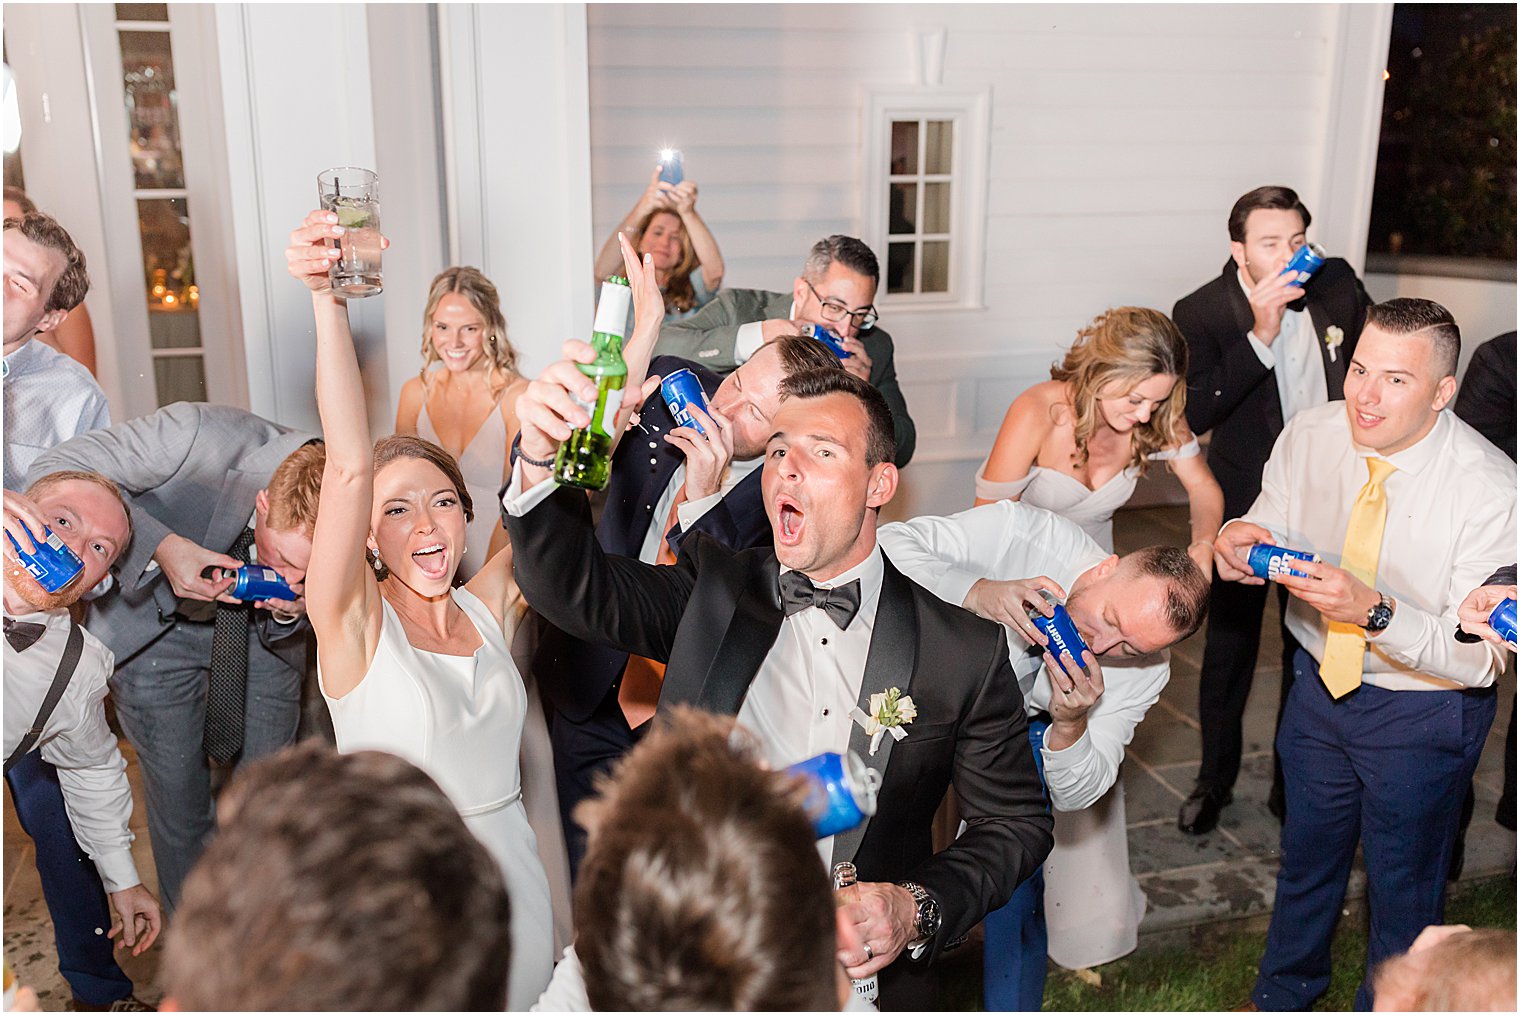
876, 500, 1172, 810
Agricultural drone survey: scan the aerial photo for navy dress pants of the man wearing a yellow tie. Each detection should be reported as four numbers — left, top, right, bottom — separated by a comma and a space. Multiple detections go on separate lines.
1251, 649, 1499, 1012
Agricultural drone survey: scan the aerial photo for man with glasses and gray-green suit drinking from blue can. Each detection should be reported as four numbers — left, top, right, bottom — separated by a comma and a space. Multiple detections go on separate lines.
655, 234, 918, 468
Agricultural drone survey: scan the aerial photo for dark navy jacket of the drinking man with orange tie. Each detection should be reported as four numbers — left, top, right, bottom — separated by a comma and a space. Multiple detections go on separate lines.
534, 356, 771, 723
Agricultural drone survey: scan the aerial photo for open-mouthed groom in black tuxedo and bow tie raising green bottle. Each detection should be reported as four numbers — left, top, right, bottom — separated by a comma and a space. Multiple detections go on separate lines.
503, 360, 1052, 1010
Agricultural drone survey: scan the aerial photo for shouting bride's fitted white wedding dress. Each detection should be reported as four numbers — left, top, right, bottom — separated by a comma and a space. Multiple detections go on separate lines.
318, 588, 555, 1010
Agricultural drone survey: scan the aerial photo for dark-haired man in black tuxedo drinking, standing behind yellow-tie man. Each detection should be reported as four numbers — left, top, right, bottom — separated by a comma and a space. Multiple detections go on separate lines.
1172, 187, 1371, 834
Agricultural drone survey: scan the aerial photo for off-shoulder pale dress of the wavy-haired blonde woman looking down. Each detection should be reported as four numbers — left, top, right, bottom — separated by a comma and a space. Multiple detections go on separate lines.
976, 439, 1201, 969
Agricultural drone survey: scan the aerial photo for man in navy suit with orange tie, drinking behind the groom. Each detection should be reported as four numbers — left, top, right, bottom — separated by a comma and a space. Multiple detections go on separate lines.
534, 336, 839, 874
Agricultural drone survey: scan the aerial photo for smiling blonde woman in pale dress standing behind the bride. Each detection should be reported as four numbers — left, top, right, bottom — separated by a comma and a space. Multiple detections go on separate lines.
395, 266, 570, 948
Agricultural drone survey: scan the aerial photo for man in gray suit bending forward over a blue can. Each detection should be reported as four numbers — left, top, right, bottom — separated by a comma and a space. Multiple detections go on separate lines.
30, 403, 324, 910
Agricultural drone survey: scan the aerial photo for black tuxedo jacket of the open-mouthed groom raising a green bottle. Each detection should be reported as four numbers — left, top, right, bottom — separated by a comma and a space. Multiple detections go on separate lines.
506, 489, 1053, 957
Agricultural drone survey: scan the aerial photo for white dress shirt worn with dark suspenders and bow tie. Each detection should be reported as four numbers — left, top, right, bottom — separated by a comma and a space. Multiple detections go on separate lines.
5, 609, 141, 892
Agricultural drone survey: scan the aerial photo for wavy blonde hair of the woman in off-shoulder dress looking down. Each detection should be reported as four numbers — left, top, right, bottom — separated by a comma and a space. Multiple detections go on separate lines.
1050, 307, 1189, 476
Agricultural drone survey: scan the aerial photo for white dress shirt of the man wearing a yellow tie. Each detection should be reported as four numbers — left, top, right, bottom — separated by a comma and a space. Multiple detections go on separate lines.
1243, 401, 1515, 691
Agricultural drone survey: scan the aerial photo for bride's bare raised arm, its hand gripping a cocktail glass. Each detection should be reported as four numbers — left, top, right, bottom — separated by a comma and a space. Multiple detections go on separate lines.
286, 211, 382, 697
